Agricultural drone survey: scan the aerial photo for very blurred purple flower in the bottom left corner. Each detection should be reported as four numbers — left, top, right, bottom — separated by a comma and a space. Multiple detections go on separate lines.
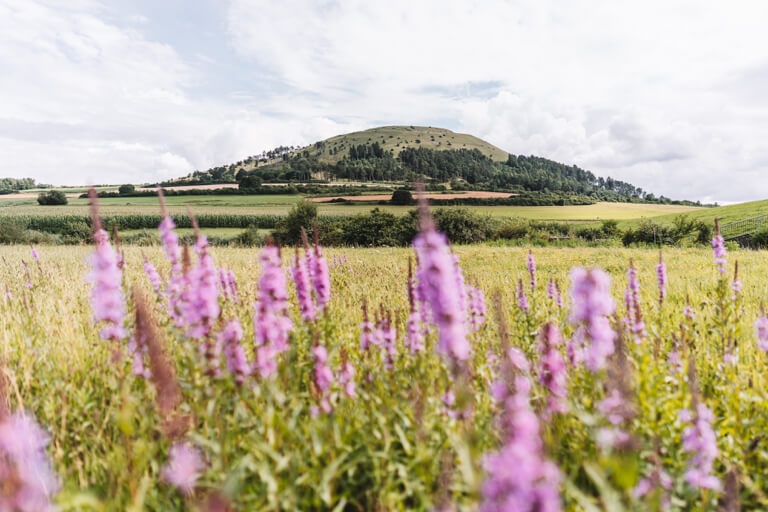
0, 413, 59, 511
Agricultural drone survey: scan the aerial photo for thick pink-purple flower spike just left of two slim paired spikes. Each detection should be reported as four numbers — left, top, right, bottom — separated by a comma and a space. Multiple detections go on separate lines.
253, 245, 293, 377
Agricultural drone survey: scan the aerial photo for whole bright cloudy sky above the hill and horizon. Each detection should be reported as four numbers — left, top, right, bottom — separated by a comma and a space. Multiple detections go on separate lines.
0, 0, 768, 203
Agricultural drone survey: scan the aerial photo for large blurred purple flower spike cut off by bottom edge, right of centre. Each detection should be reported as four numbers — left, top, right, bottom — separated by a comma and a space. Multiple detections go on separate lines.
479, 376, 561, 512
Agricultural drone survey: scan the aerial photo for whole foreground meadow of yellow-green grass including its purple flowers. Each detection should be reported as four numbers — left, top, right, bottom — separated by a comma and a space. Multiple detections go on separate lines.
0, 201, 768, 511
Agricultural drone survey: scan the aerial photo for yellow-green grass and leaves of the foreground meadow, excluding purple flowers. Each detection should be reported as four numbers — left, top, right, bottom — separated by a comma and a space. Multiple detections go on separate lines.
0, 242, 768, 511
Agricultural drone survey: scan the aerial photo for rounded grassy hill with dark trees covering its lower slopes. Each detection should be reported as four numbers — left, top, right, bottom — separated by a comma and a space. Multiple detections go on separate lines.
161, 126, 700, 206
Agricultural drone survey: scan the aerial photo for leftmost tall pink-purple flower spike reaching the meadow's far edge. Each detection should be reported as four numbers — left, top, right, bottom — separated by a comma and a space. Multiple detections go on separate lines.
88, 229, 126, 340
